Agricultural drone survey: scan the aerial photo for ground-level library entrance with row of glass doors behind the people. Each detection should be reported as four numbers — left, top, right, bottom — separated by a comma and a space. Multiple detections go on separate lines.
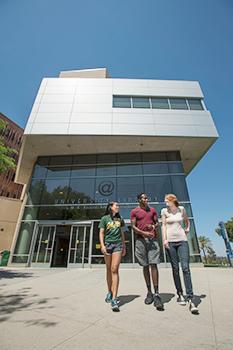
28, 219, 166, 268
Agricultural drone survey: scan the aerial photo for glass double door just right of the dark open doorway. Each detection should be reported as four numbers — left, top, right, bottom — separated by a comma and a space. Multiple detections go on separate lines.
68, 225, 91, 267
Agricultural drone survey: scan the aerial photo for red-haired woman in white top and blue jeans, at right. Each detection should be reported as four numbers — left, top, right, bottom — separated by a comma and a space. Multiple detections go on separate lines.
161, 194, 198, 313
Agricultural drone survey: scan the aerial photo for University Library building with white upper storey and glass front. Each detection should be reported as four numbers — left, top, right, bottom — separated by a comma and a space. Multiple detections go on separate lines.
12, 69, 218, 267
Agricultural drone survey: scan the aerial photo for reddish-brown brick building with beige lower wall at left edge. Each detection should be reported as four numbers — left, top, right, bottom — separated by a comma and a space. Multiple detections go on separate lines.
0, 113, 24, 251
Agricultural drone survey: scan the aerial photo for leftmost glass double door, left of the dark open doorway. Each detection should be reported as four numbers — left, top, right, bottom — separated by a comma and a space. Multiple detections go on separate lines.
31, 225, 56, 267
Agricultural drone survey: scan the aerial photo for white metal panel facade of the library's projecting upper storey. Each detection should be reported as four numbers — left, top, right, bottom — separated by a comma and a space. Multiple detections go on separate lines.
25, 78, 218, 137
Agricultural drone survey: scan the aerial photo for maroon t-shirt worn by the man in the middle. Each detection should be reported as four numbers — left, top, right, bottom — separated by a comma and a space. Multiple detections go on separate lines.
130, 206, 157, 238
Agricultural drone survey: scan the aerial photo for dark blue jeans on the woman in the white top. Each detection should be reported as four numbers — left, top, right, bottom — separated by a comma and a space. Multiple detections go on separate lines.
167, 241, 193, 299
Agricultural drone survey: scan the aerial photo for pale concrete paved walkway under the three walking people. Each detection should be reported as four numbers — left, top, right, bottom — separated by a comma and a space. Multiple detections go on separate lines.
0, 268, 233, 350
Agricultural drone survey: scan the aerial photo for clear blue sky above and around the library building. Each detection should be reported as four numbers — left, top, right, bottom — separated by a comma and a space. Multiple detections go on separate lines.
0, 0, 233, 255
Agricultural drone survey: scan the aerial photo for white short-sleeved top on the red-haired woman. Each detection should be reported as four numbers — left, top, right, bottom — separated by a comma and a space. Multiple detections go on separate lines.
161, 206, 187, 242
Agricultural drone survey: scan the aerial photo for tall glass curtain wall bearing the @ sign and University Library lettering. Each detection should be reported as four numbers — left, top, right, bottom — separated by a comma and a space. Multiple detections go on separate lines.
12, 152, 200, 263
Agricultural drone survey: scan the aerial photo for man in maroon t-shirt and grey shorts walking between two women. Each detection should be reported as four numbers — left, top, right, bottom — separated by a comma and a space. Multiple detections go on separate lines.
130, 193, 163, 310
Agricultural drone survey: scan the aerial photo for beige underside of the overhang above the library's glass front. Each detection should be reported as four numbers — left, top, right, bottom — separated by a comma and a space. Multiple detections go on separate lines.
16, 135, 218, 184
